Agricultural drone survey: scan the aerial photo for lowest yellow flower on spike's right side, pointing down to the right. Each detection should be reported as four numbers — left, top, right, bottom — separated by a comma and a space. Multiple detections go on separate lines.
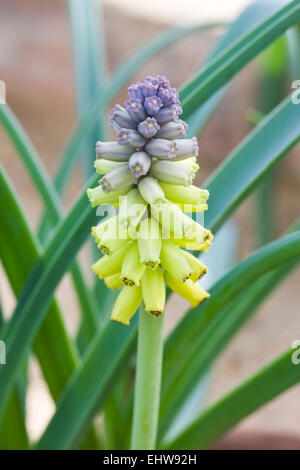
165, 273, 210, 307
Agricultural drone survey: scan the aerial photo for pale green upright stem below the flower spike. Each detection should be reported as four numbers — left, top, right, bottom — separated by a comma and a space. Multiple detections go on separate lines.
131, 307, 164, 450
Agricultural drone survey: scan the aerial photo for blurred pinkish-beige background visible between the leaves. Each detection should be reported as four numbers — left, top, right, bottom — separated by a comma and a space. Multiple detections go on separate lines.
0, 0, 300, 448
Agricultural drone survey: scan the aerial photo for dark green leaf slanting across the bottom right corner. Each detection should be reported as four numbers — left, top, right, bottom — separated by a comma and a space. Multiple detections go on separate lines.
162, 350, 300, 450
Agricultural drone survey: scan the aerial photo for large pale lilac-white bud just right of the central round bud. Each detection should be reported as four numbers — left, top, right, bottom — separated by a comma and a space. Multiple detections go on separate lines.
151, 161, 196, 186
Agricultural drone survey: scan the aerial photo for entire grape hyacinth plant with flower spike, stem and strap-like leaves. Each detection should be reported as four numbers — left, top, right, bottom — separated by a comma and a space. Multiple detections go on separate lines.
0, 0, 300, 458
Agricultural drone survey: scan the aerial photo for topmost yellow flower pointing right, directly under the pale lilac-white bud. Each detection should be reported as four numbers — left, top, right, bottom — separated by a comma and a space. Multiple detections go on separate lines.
159, 182, 209, 205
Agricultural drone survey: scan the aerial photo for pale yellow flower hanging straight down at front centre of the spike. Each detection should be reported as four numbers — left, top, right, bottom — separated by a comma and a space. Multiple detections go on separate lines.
137, 217, 161, 269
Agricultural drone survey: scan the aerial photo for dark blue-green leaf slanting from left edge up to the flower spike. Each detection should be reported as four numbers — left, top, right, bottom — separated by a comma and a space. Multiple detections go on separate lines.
0, 172, 96, 422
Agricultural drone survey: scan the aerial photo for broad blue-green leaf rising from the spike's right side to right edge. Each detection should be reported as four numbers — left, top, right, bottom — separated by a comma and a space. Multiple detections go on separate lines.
205, 97, 300, 230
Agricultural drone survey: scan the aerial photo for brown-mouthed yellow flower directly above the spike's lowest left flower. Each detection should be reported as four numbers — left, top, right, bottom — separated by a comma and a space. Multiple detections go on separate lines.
121, 241, 146, 286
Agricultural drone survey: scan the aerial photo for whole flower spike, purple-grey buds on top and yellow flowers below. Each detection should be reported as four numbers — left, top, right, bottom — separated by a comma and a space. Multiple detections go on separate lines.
87, 75, 213, 325
